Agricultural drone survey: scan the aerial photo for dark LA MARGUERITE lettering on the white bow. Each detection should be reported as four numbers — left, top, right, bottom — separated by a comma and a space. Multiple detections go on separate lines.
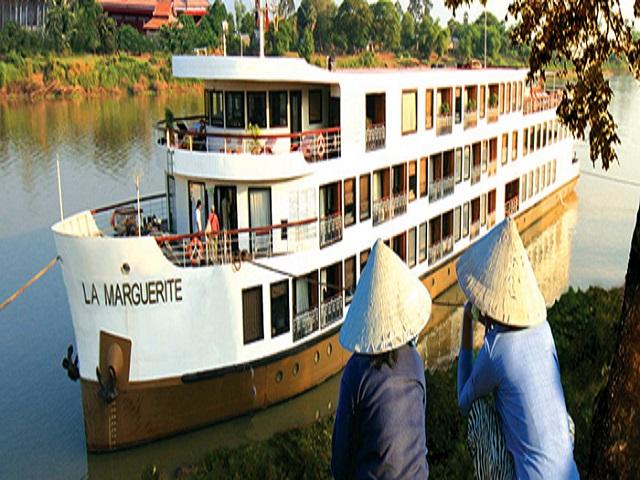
82, 278, 182, 307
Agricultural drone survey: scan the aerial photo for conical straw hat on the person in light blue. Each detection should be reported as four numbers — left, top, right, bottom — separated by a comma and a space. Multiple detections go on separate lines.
456, 217, 547, 327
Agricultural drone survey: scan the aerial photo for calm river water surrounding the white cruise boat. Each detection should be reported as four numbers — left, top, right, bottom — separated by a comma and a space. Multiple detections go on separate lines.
0, 77, 640, 478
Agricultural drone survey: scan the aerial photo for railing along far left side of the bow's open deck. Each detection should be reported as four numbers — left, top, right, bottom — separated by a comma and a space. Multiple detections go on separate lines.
91, 193, 169, 237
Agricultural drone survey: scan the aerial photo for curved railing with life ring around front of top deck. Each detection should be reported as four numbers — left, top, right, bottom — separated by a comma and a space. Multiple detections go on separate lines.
157, 117, 342, 162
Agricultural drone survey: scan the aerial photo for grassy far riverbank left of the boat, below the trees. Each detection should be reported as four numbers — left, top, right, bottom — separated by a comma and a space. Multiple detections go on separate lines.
0, 54, 200, 99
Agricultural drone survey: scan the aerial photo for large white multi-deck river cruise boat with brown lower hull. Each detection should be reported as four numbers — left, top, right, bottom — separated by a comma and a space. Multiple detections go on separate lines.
52, 56, 579, 451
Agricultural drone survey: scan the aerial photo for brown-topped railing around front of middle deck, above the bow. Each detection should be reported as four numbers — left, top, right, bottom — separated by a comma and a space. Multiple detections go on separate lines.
155, 218, 318, 267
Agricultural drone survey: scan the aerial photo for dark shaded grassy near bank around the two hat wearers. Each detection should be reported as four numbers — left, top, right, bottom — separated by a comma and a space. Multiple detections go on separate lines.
164, 287, 622, 479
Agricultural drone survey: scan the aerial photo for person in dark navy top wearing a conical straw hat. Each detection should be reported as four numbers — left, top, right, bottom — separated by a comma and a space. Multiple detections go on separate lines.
331, 240, 431, 480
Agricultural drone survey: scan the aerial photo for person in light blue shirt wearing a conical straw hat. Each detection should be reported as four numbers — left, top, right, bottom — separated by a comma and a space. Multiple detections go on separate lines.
456, 217, 579, 480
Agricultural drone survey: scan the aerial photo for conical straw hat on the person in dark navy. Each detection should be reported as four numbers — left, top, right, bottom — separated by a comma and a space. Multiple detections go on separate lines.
340, 240, 431, 354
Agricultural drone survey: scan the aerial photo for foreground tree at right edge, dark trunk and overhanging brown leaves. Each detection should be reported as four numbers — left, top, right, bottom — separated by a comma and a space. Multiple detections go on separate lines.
445, 0, 640, 478
